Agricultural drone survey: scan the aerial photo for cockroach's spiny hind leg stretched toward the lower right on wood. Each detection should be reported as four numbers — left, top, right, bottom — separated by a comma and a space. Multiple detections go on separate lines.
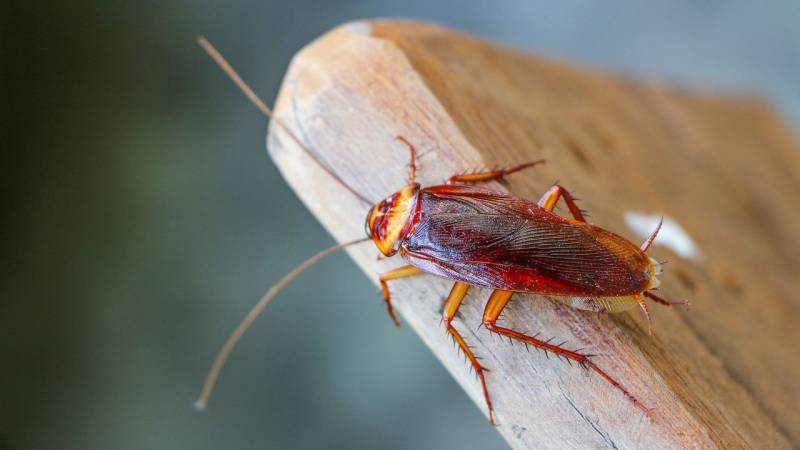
483, 289, 650, 414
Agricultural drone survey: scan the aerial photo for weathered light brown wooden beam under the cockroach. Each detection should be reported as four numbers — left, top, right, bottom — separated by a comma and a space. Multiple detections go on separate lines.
268, 22, 800, 448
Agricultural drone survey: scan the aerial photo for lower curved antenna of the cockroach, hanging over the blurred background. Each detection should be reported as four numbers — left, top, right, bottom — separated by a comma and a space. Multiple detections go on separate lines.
194, 238, 370, 411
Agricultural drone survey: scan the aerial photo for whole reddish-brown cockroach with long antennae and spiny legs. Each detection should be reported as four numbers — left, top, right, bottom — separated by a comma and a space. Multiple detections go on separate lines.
196, 37, 687, 425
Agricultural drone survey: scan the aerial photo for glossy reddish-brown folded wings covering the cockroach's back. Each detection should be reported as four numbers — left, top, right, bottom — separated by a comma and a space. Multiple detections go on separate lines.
401, 185, 649, 296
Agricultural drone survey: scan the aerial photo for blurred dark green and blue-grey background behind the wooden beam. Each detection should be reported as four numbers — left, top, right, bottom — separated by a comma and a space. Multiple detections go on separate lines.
0, 0, 800, 449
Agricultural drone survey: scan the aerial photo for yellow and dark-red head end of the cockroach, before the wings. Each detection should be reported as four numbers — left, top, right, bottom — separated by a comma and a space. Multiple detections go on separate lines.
364, 183, 420, 256
